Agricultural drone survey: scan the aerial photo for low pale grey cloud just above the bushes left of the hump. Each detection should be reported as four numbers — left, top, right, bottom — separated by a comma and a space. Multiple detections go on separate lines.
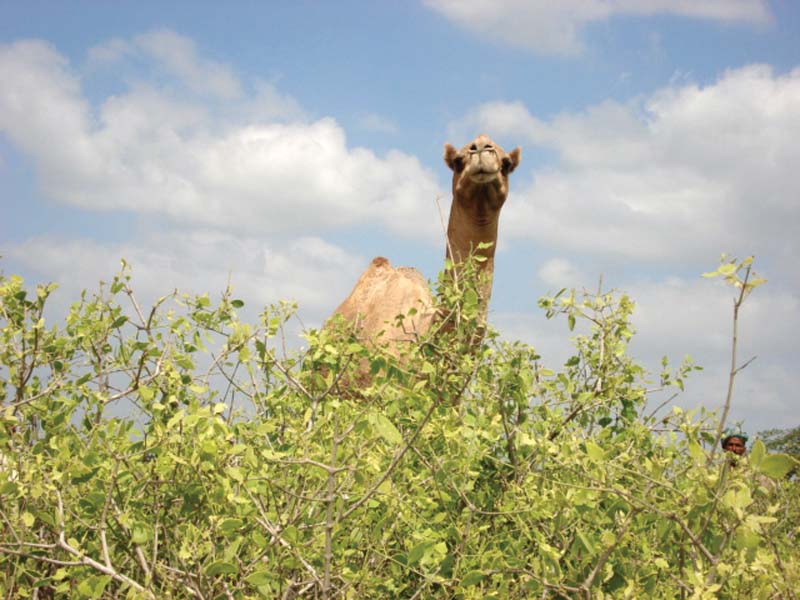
3, 230, 367, 327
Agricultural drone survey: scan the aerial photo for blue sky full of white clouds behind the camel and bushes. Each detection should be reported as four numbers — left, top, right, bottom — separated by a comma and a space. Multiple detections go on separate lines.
0, 0, 800, 433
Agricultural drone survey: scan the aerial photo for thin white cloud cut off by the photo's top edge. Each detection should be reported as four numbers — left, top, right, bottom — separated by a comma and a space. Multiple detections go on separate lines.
425, 0, 771, 56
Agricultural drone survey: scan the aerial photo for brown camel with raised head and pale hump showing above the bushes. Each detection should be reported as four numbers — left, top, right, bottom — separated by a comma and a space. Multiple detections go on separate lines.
334, 135, 521, 355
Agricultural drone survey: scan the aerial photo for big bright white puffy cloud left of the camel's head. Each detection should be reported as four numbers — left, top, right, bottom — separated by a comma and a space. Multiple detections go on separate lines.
0, 32, 441, 239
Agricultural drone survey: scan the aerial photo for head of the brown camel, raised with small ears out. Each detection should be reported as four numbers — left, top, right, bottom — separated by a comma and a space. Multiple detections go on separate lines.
444, 134, 522, 217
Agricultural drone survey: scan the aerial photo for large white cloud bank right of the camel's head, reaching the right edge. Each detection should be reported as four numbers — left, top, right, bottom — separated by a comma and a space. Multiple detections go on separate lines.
451, 65, 800, 274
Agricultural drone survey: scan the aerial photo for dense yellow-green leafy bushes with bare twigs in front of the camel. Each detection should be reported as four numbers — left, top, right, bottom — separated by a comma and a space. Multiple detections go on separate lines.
0, 258, 800, 599
